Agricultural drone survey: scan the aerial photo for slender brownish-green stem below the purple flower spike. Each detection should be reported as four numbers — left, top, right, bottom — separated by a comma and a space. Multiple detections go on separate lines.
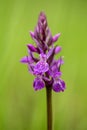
46, 86, 52, 130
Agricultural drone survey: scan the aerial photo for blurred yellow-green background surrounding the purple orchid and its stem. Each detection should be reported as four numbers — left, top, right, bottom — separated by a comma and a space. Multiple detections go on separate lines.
0, 0, 87, 130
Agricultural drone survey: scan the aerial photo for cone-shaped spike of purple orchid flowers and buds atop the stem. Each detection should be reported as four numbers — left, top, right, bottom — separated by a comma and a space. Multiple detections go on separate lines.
21, 12, 66, 92
